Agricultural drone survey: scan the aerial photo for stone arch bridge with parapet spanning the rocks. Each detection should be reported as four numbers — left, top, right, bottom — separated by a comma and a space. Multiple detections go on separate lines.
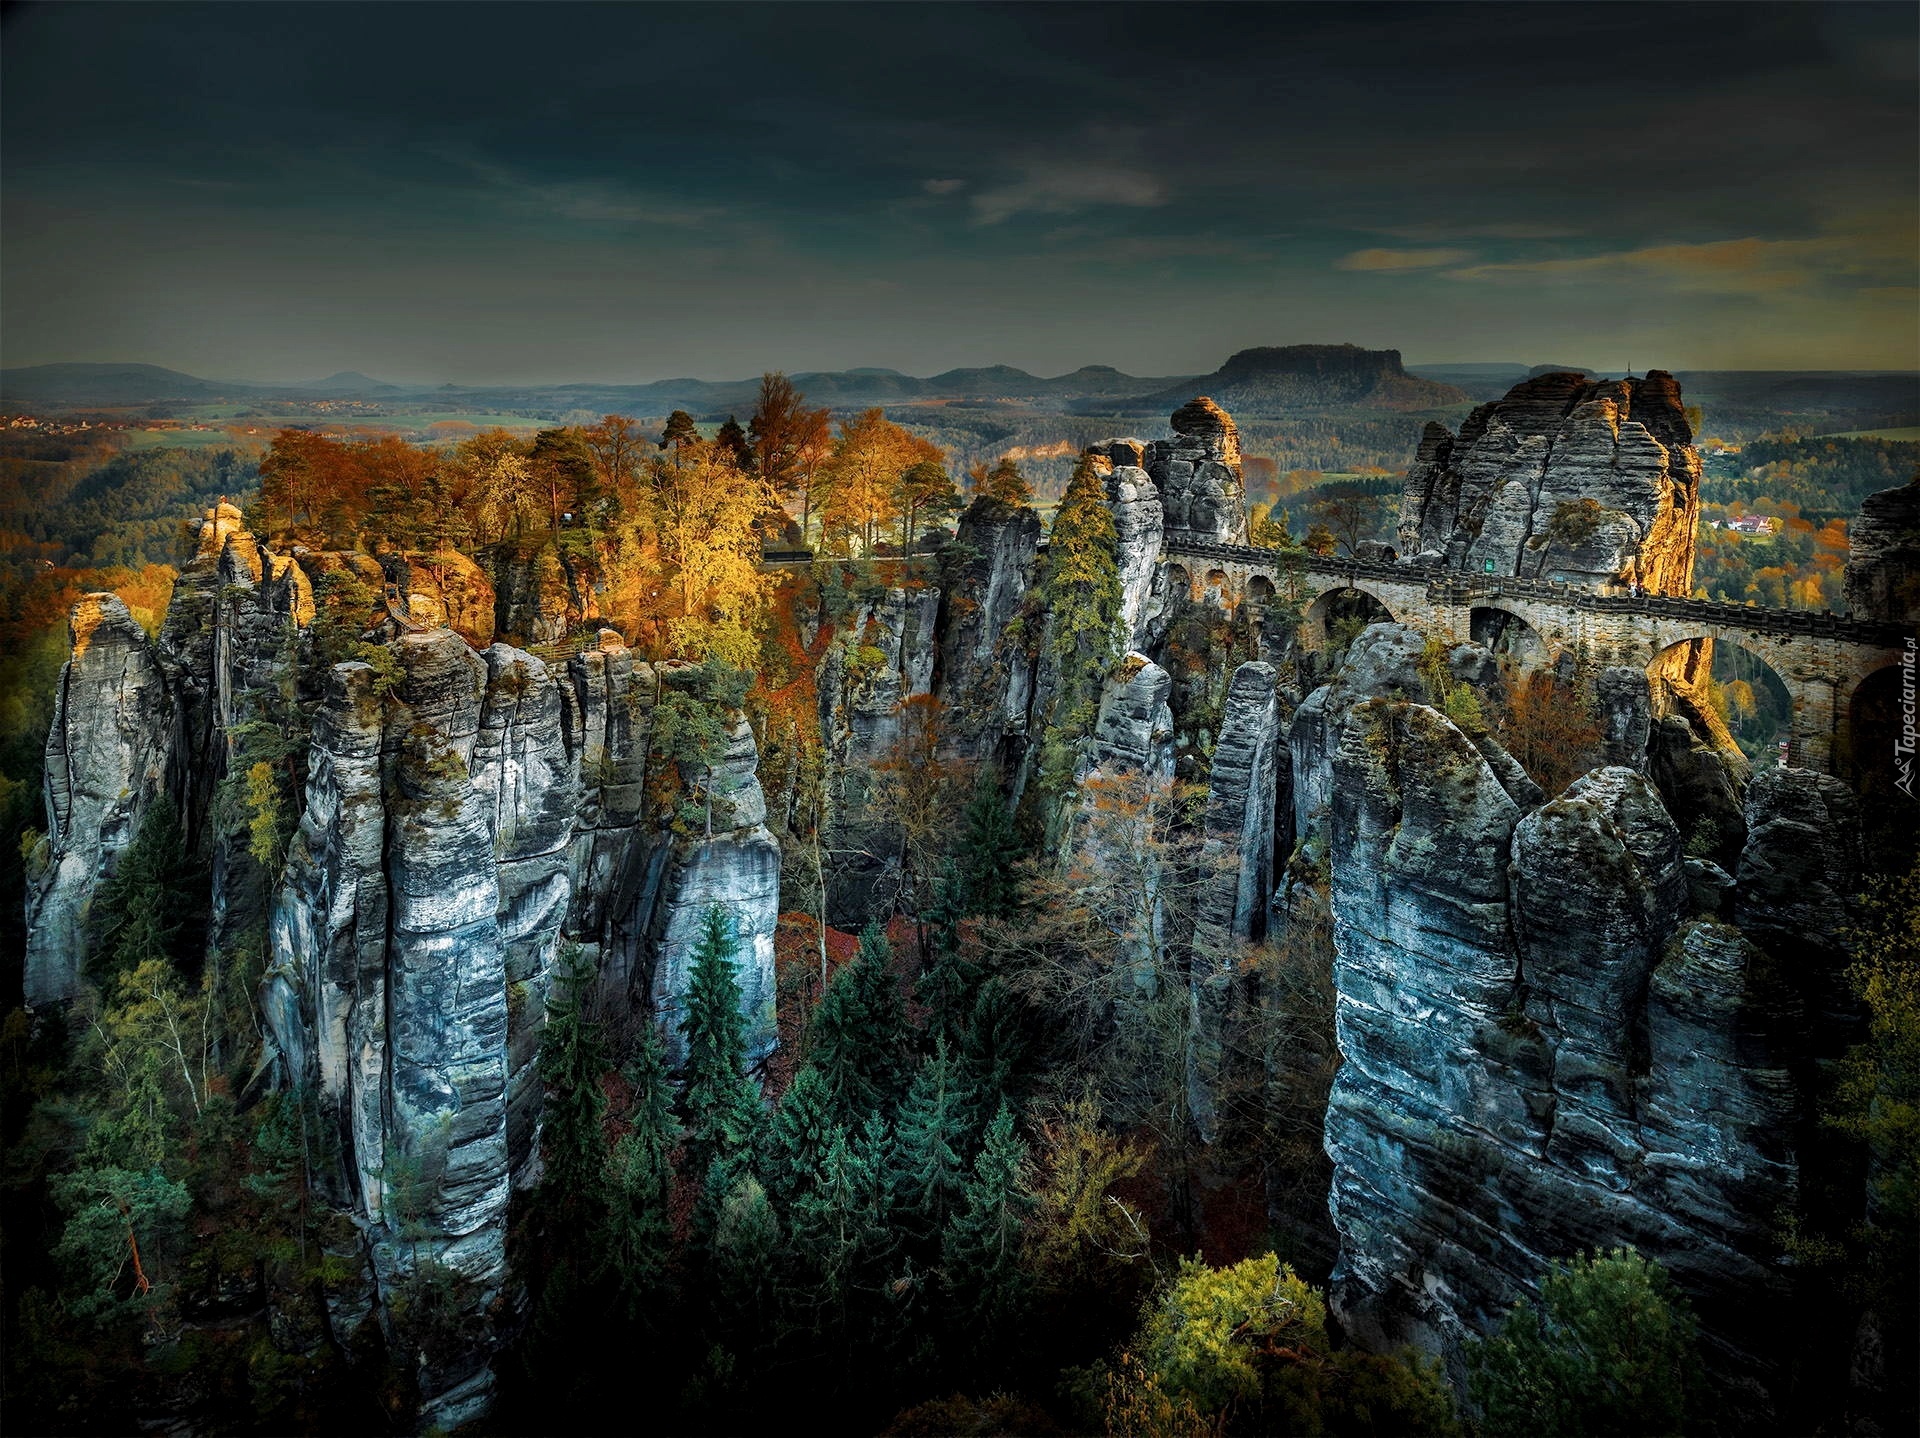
1160, 538, 1914, 772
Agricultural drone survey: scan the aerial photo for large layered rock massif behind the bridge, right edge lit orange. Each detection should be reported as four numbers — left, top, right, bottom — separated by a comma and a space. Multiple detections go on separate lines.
1400, 371, 1701, 595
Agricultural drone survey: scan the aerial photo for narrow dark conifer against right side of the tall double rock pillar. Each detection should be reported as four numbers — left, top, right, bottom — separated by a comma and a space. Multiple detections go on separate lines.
540, 945, 607, 1227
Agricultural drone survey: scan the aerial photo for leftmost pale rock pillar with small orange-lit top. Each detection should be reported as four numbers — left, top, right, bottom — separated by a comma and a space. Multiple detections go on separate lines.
27, 593, 175, 1004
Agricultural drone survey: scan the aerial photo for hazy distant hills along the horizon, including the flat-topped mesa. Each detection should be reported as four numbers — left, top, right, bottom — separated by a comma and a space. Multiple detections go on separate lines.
0, 344, 1920, 419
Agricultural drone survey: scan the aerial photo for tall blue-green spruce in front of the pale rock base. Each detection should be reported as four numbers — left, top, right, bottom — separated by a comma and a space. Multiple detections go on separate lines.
680, 904, 760, 1198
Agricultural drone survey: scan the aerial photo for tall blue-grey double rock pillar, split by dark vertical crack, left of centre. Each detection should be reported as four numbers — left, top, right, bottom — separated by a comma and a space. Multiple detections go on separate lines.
263, 630, 541, 1423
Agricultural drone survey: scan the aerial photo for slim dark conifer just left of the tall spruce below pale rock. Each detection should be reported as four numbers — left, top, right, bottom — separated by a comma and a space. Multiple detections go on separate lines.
605, 1023, 678, 1321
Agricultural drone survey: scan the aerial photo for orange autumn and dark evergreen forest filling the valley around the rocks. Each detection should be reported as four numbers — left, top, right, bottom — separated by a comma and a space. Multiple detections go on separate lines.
0, 376, 1920, 1438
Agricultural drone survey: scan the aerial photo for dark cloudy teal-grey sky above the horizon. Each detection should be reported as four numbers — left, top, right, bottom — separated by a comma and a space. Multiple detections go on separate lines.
0, 4, 1920, 382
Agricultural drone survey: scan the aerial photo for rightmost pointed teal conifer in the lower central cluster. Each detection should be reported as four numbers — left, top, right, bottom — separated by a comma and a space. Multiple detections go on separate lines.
941, 1104, 1033, 1363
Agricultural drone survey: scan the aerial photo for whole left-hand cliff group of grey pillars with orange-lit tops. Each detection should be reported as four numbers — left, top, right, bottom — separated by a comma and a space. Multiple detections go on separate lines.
27, 505, 779, 1426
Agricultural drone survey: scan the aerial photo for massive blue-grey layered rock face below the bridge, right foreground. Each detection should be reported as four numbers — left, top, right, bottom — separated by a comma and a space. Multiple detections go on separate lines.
1325, 683, 1795, 1405
